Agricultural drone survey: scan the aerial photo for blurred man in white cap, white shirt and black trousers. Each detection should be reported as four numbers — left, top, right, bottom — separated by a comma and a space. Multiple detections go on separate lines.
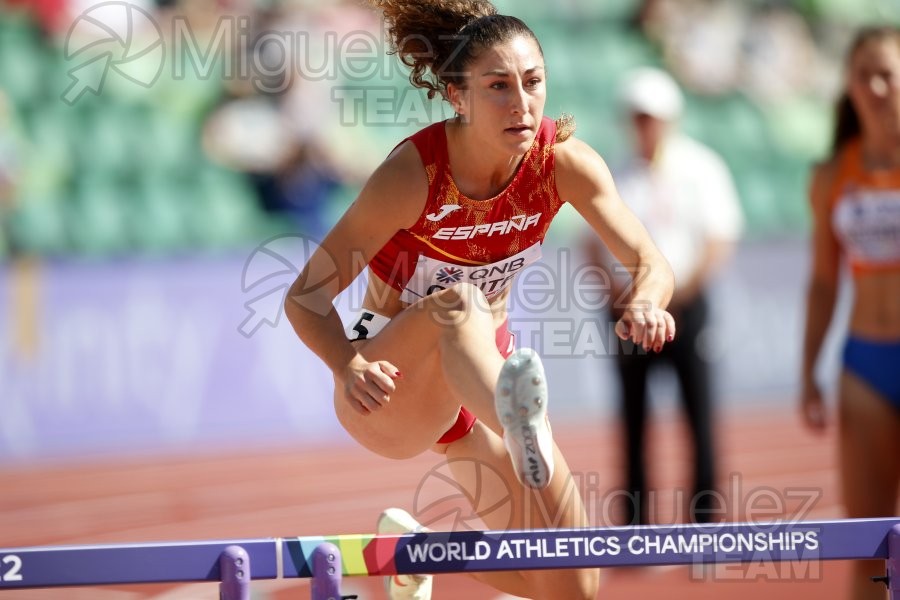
589, 68, 743, 523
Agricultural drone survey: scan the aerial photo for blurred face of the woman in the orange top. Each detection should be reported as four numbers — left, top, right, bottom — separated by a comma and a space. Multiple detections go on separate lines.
847, 38, 900, 132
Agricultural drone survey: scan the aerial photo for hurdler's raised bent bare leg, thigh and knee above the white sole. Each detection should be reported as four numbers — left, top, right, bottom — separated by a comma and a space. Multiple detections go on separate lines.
335, 284, 503, 458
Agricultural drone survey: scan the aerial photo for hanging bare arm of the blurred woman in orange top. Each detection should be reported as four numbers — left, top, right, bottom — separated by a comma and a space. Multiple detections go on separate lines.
800, 163, 840, 429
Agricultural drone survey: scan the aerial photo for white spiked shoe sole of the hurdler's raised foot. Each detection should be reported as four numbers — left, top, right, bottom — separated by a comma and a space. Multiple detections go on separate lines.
495, 348, 553, 489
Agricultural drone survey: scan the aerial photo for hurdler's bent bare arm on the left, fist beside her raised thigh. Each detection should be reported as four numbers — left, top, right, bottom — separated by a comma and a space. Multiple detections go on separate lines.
285, 142, 428, 412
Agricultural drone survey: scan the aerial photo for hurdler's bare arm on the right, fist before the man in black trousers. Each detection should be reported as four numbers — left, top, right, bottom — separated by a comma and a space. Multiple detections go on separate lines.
555, 138, 675, 351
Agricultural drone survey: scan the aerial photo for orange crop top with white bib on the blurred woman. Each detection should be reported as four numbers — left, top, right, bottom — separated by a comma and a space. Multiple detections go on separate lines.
830, 139, 900, 275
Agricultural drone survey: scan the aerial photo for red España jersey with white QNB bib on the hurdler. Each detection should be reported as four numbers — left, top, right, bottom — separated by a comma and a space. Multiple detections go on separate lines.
369, 117, 562, 303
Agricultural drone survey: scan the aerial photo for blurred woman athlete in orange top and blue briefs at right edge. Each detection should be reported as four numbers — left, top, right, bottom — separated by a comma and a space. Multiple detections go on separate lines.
800, 27, 900, 600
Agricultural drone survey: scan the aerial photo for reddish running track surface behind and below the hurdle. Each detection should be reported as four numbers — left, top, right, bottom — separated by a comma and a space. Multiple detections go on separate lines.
0, 401, 884, 600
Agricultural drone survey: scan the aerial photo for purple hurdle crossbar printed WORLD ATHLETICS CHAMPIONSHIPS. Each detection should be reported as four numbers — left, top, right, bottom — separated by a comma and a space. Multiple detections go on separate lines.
0, 517, 900, 600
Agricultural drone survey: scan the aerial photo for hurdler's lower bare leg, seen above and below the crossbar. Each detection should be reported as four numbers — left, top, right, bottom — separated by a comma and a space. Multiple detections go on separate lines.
446, 422, 600, 600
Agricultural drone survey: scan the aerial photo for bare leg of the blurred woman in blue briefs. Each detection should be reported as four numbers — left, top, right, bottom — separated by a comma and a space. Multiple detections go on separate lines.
840, 371, 900, 600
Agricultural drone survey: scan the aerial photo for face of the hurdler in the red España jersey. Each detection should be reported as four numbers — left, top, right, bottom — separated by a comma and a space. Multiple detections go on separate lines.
449, 36, 547, 155
